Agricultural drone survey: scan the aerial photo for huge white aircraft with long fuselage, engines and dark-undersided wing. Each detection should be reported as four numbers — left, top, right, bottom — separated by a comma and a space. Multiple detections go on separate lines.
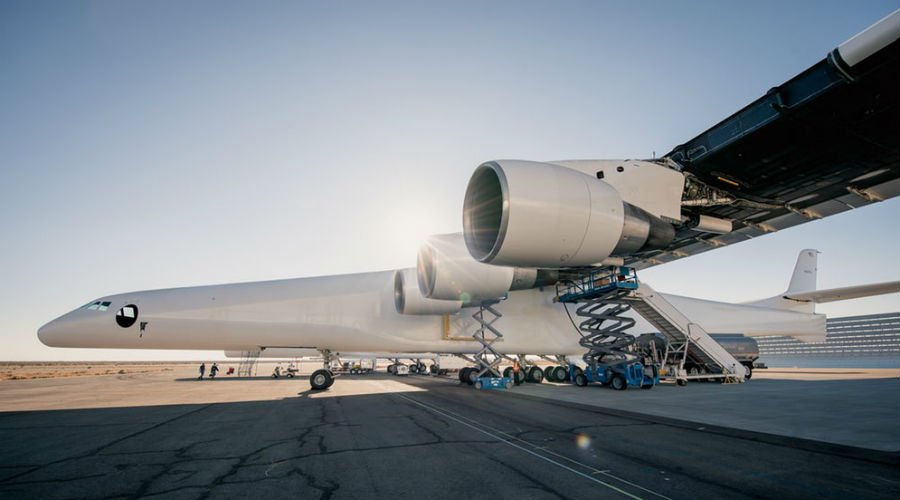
38, 11, 900, 388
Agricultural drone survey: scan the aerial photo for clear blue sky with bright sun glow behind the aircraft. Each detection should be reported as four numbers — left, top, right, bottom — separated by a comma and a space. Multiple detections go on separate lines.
0, 0, 900, 359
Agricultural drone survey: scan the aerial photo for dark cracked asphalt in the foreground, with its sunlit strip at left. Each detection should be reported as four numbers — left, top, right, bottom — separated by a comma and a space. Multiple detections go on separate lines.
0, 373, 900, 499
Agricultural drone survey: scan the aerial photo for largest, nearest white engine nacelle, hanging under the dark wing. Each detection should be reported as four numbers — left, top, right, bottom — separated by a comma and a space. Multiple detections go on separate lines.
463, 160, 683, 268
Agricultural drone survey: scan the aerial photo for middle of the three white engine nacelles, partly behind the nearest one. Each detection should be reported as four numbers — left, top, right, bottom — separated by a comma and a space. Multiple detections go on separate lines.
416, 233, 557, 306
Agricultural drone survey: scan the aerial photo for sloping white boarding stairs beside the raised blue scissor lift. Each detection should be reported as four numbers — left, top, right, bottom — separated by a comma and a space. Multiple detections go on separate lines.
624, 283, 747, 382
